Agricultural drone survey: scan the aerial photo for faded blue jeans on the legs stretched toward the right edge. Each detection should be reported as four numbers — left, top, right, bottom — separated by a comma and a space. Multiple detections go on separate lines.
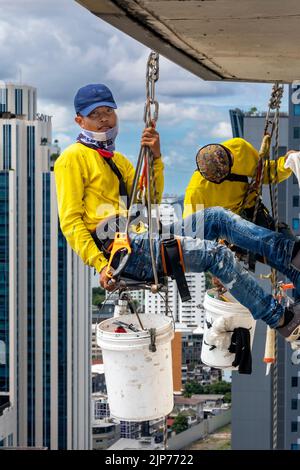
124, 207, 300, 328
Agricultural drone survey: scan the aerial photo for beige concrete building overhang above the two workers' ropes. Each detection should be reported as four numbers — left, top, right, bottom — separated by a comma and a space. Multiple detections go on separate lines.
76, 0, 300, 83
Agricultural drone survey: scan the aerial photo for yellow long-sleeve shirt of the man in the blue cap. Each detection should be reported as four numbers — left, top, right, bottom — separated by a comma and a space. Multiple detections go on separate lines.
54, 143, 164, 272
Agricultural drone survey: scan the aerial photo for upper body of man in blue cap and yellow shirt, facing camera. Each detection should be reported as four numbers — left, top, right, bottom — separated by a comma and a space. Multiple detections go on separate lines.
54, 84, 164, 288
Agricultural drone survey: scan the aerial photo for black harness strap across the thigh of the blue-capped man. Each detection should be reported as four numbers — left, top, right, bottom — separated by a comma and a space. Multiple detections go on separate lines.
161, 238, 191, 302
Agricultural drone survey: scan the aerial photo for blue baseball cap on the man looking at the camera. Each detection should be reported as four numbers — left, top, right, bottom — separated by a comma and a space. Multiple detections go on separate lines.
74, 83, 117, 116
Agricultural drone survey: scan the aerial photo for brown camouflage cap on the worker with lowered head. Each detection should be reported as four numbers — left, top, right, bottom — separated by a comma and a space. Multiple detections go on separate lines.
196, 144, 233, 184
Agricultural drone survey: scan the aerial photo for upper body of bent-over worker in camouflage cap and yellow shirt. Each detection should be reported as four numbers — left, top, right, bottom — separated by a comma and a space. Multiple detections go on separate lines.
183, 138, 292, 224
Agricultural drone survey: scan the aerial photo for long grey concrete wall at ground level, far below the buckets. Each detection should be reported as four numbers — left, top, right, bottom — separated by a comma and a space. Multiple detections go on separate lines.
168, 410, 231, 450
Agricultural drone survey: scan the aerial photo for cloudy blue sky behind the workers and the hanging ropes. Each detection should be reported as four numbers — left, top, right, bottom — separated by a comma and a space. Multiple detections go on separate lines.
0, 0, 286, 194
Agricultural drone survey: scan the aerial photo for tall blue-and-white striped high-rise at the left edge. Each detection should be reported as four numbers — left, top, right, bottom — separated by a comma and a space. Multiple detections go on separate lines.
0, 83, 91, 449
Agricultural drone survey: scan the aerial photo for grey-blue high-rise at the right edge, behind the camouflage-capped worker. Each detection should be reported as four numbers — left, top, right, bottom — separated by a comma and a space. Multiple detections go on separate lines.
230, 88, 300, 449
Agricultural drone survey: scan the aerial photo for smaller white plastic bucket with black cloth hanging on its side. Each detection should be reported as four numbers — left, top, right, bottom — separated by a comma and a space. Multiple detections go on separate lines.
201, 289, 256, 370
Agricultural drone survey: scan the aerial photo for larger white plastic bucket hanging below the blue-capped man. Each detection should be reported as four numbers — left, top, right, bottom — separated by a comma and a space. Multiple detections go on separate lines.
97, 314, 174, 421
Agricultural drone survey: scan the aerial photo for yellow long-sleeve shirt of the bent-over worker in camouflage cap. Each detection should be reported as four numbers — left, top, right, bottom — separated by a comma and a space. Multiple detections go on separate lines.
183, 138, 291, 217
